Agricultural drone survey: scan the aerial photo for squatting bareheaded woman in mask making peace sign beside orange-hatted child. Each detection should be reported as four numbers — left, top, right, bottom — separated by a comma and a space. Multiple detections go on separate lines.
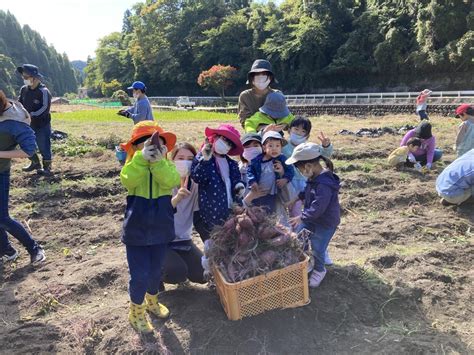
162, 143, 205, 284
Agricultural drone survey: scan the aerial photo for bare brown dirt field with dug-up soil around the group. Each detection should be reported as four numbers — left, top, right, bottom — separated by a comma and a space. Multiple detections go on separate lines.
0, 110, 474, 354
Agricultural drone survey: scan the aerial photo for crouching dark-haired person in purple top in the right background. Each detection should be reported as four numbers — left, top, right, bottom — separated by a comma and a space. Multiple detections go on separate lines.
400, 120, 443, 170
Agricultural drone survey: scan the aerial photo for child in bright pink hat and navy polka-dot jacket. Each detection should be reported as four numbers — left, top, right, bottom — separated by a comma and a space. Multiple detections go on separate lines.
191, 124, 245, 241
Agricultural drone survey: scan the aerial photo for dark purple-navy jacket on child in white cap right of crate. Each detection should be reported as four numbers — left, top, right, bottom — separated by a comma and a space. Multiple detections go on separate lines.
300, 171, 341, 229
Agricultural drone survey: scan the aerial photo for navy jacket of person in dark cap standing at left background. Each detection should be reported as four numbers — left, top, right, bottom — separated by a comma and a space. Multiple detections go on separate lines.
18, 84, 51, 129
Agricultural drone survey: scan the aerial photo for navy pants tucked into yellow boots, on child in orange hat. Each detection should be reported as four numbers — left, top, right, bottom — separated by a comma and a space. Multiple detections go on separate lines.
126, 244, 168, 304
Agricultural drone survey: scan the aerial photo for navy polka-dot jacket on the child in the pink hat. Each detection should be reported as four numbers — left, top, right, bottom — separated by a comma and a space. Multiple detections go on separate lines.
191, 153, 242, 227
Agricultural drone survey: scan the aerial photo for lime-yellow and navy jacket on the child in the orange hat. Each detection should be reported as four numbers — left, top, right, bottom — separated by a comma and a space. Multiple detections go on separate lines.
120, 150, 180, 246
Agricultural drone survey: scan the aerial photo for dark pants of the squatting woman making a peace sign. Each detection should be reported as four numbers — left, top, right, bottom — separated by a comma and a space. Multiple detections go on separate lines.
162, 241, 206, 284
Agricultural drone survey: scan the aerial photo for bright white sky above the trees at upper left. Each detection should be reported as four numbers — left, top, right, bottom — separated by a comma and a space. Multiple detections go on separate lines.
0, 0, 143, 61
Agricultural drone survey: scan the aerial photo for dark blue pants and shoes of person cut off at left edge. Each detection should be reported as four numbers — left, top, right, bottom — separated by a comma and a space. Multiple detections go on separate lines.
0, 172, 39, 256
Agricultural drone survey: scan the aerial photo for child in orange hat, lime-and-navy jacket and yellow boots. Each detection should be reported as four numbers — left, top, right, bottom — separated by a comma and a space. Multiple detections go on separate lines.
120, 121, 180, 333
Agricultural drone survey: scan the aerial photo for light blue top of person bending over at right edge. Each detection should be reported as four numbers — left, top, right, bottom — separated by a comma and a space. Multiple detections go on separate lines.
436, 149, 474, 197
